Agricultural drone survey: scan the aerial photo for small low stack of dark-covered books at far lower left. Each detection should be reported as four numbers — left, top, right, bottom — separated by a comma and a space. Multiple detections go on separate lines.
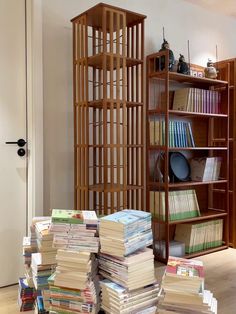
18, 277, 36, 312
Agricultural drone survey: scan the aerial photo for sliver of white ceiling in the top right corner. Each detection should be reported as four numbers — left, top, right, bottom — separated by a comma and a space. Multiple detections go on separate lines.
185, 0, 236, 18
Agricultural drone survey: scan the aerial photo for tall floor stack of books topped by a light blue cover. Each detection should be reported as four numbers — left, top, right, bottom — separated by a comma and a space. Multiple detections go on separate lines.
99, 210, 159, 314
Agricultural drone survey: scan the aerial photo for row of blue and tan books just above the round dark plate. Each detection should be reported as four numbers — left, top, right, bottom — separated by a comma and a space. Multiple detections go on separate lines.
149, 118, 195, 147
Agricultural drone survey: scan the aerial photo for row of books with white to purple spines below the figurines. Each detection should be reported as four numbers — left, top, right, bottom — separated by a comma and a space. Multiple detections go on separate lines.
172, 87, 221, 114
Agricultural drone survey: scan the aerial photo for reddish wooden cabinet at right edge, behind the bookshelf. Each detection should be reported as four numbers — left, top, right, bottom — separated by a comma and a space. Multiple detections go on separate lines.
214, 58, 236, 248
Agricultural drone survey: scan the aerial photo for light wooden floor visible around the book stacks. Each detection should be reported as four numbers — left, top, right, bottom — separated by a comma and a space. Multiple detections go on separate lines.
0, 249, 236, 314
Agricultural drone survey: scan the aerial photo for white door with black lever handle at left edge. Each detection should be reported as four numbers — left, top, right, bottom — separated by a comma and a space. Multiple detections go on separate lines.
0, 0, 27, 287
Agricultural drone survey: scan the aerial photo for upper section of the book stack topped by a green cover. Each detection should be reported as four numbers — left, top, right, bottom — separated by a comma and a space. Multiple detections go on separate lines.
50, 209, 99, 253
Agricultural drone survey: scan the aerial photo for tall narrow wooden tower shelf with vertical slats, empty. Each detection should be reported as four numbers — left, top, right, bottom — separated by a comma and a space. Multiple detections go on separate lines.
72, 3, 145, 214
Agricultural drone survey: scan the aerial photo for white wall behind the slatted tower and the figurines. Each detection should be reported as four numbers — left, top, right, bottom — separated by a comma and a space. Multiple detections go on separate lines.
42, 0, 236, 213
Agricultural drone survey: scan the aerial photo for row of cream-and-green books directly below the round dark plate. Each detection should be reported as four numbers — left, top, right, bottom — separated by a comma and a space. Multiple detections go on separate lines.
149, 190, 200, 221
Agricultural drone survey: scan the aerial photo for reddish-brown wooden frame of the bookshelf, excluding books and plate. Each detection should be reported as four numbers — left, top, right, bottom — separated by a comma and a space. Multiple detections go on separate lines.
146, 50, 229, 262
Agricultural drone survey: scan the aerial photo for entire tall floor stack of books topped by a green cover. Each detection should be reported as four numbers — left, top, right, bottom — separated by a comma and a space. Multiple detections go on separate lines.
48, 209, 99, 313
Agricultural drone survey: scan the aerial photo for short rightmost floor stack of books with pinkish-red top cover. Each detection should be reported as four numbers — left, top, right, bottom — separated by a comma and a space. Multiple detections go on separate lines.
158, 256, 217, 314
